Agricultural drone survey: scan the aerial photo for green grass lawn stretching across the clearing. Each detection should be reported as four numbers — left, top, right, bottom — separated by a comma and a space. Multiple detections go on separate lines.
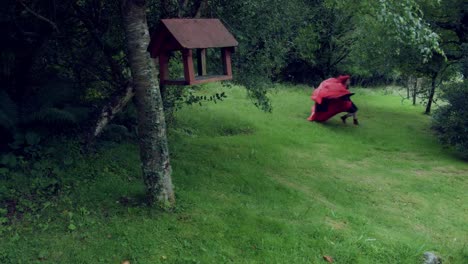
0, 85, 468, 264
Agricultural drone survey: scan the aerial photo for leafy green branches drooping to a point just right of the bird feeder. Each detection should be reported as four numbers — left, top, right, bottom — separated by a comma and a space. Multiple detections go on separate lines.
207, 0, 307, 111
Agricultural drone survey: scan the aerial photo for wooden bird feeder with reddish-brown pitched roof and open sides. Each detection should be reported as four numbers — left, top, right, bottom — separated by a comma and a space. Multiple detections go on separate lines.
148, 19, 238, 85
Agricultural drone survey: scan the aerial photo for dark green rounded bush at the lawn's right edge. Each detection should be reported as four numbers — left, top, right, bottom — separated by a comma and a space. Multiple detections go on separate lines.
432, 80, 468, 159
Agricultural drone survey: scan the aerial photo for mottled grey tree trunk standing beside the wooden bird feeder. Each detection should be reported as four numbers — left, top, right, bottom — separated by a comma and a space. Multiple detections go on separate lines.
122, 0, 175, 206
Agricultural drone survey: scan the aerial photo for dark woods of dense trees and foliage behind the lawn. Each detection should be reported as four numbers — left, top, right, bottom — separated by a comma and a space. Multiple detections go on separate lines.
0, 0, 468, 154
